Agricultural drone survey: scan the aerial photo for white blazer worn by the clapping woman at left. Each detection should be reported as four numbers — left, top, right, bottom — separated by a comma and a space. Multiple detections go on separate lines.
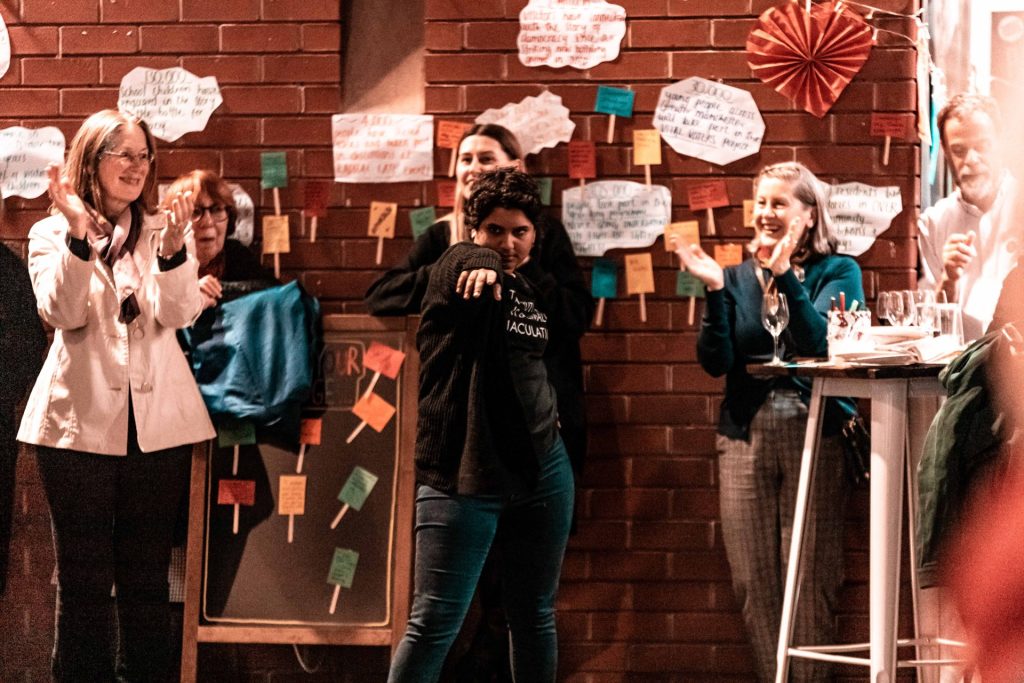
18, 209, 215, 456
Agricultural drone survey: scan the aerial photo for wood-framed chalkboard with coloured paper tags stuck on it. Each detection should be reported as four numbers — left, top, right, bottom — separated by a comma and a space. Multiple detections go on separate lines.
182, 315, 418, 680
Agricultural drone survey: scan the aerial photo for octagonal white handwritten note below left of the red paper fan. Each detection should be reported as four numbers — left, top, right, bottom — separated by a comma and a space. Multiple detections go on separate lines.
654, 76, 765, 165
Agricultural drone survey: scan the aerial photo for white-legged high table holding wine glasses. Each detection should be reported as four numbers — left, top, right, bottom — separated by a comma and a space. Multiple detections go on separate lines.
748, 364, 953, 683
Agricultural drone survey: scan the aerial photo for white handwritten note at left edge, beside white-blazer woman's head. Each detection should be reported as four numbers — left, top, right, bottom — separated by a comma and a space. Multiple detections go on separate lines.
0, 126, 65, 199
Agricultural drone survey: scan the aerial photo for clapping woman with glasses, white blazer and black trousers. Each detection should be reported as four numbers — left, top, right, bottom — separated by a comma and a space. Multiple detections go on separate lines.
18, 110, 214, 681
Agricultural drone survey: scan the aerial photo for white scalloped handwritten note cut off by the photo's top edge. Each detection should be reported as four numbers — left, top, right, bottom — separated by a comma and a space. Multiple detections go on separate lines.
516, 0, 626, 69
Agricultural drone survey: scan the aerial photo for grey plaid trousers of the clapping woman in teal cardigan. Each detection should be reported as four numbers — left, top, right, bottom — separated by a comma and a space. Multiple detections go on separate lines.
717, 389, 849, 682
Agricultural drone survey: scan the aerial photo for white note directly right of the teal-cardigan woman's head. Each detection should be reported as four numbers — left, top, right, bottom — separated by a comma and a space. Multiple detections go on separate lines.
828, 182, 903, 256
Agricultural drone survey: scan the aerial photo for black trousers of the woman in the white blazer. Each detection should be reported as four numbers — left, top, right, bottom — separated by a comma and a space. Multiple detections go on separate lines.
37, 429, 191, 683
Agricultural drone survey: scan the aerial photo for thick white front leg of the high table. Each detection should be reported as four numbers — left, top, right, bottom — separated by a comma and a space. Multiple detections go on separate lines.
868, 381, 907, 683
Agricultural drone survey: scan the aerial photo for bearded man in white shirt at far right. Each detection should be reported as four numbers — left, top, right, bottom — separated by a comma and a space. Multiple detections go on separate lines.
918, 93, 1019, 341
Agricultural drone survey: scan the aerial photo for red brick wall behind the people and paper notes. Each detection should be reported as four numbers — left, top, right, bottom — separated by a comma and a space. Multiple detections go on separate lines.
0, 0, 919, 683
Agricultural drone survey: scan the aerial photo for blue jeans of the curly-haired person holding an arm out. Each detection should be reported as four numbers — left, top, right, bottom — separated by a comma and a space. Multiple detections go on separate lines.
388, 438, 573, 683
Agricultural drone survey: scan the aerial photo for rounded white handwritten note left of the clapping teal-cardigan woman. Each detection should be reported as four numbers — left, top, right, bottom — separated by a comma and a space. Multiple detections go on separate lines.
562, 180, 672, 256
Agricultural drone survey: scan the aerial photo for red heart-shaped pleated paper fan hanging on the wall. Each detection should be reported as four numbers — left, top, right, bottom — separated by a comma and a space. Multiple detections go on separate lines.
746, 2, 872, 119
